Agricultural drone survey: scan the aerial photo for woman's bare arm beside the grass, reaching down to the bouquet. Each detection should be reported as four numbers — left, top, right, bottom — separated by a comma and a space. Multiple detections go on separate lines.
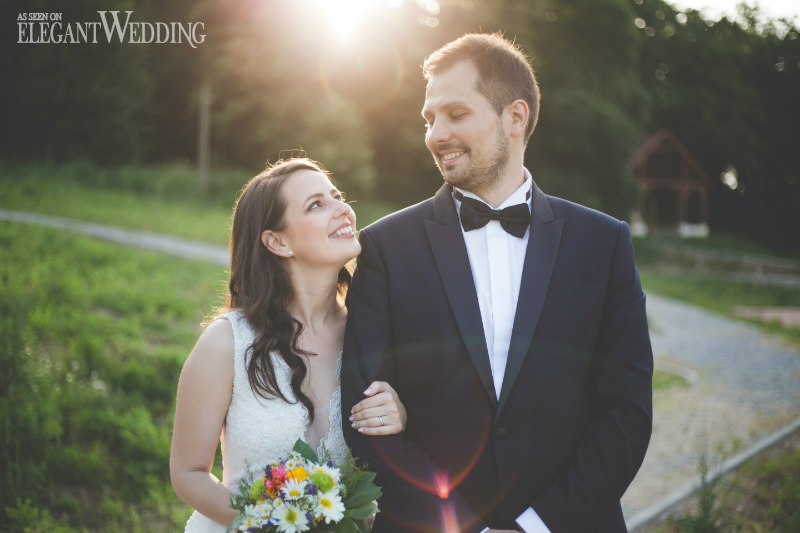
169, 320, 238, 526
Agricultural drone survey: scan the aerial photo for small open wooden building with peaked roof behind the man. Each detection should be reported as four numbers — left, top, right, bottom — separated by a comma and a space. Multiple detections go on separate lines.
631, 130, 711, 237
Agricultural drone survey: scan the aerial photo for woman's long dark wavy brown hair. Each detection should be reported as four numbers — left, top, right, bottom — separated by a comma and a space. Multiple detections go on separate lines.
226, 158, 351, 423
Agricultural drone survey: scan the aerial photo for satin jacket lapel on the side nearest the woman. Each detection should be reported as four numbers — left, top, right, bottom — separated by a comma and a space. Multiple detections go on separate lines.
425, 185, 497, 407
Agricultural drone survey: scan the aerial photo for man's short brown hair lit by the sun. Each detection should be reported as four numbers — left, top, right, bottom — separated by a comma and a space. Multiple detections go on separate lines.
422, 33, 539, 142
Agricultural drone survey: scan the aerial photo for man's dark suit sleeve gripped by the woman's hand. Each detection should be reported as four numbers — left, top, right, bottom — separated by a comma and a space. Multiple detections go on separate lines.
341, 230, 485, 533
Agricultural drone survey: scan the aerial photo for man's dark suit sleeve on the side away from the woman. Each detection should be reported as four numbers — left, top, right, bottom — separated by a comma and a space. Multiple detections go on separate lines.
532, 219, 653, 531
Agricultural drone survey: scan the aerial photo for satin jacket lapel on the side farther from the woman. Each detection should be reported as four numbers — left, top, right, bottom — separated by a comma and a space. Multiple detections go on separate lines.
498, 184, 564, 413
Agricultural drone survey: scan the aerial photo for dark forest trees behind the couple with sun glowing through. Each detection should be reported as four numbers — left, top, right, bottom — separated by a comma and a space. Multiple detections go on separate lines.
0, 0, 800, 252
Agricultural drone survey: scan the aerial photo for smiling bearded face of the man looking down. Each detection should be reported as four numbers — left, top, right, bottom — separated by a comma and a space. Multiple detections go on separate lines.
422, 61, 509, 196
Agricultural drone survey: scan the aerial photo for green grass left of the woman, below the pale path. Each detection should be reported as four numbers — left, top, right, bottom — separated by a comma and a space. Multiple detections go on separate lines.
0, 222, 226, 531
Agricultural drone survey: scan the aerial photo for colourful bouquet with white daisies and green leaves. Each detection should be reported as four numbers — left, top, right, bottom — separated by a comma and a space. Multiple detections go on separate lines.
227, 439, 381, 533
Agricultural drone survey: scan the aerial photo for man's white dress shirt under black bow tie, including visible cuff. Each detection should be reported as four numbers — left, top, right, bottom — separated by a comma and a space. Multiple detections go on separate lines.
453, 169, 550, 533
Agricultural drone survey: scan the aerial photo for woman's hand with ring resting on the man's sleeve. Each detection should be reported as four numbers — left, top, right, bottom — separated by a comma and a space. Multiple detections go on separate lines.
350, 381, 406, 435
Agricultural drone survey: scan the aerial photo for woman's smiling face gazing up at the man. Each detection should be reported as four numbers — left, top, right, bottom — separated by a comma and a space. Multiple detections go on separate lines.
278, 170, 361, 267
